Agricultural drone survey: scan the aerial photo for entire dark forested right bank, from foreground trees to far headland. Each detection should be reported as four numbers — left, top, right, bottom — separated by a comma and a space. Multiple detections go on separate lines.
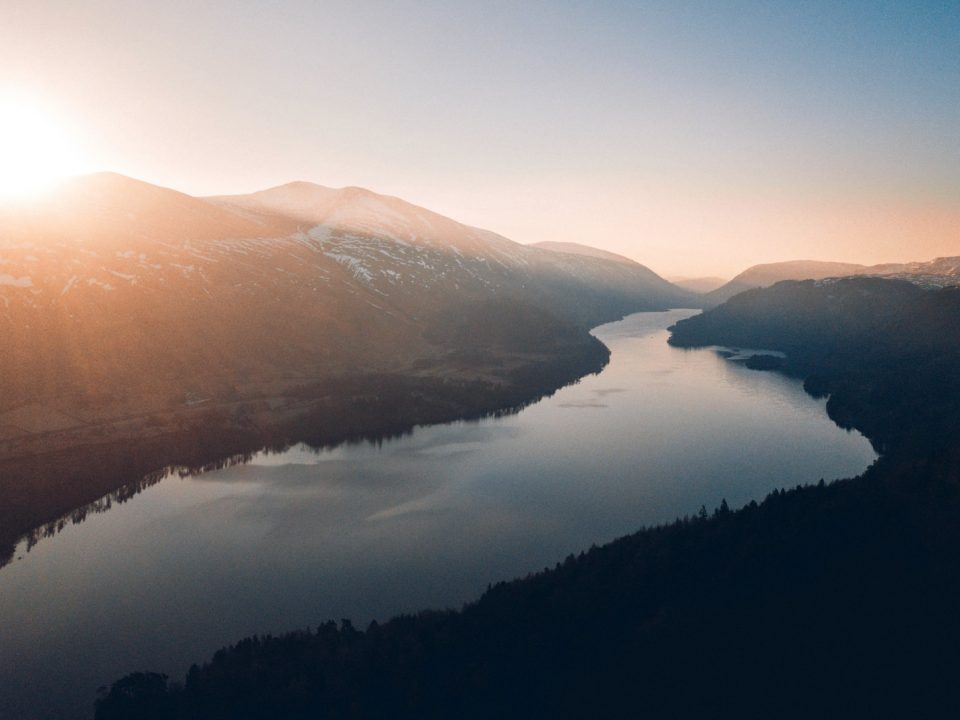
97, 279, 960, 720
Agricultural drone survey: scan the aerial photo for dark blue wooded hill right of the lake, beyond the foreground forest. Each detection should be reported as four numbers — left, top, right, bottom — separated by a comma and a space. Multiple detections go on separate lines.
670, 277, 960, 455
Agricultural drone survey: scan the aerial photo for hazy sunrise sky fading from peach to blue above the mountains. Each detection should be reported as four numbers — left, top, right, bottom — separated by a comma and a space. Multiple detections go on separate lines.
0, 0, 960, 277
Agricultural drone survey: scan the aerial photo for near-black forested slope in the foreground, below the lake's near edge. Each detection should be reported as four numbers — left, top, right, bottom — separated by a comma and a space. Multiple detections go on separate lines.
98, 458, 960, 720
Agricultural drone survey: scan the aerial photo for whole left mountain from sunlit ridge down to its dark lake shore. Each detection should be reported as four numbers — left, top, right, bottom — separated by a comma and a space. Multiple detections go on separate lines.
0, 173, 694, 561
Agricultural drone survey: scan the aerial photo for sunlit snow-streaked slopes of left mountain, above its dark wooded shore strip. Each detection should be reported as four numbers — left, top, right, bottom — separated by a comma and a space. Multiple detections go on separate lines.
0, 174, 691, 420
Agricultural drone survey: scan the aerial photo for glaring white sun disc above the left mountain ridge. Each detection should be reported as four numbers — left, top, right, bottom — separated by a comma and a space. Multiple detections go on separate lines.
0, 97, 85, 200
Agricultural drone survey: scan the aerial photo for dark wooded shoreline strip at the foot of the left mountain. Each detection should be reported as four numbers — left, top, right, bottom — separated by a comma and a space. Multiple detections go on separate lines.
0, 333, 610, 568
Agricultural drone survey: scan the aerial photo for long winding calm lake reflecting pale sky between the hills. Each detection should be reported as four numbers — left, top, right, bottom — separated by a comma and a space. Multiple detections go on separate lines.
0, 311, 875, 718
